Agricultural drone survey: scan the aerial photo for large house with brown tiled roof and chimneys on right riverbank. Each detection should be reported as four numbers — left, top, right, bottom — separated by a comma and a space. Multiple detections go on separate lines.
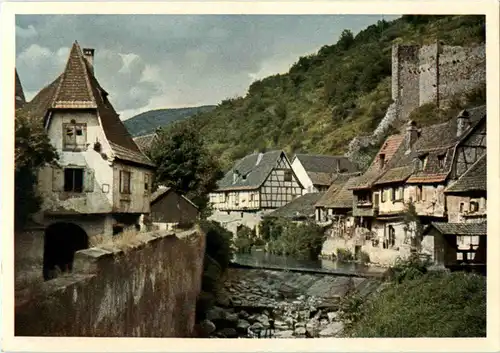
344, 106, 486, 263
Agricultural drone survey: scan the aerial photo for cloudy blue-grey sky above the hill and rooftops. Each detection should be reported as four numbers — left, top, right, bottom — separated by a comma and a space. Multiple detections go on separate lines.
16, 15, 397, 120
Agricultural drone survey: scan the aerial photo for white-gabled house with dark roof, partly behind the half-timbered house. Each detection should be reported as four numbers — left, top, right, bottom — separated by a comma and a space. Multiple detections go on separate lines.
292, 154, 357, 193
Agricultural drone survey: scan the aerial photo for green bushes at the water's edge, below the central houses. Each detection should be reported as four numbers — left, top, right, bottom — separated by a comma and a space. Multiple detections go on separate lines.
263, 218, 326, 259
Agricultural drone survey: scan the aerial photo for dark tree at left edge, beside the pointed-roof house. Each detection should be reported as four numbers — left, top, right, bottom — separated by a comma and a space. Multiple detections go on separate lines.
14, 111, 58, 228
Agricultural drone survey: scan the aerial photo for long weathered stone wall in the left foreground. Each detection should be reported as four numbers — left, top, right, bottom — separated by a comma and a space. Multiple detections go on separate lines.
15, 230, 205, 337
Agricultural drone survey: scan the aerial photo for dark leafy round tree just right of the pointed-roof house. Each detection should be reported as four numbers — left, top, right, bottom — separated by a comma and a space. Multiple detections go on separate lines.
149, 122, 223, 217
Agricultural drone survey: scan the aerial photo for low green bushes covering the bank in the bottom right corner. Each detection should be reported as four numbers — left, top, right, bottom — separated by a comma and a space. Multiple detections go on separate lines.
345, 272, 486, 337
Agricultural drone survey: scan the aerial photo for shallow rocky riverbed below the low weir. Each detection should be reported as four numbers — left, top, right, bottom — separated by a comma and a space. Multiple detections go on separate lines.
201, 268, 380, 338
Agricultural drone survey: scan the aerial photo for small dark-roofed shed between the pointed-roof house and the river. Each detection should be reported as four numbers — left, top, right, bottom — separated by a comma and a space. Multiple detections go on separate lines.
144, 186, 200, 230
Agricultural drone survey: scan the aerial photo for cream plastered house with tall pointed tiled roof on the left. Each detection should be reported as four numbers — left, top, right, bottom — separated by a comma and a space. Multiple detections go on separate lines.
17, 42, 154, 274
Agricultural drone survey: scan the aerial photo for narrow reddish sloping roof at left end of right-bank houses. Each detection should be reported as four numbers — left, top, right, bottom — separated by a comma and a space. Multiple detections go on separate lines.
351, 134, 405, 189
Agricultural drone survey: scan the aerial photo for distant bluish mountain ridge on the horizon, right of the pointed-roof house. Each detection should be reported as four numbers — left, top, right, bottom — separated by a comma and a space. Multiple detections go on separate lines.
123, 105, 215, 137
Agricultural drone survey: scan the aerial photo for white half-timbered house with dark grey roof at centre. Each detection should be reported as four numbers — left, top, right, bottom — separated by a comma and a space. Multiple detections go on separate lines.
209, 151, 303, 233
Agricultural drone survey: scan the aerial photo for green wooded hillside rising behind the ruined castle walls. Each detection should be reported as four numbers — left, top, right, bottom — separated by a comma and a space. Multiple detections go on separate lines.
172, 15, 485, 167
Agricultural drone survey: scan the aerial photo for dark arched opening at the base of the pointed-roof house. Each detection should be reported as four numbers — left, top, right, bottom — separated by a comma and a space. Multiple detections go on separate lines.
43, 222, 89, 280
